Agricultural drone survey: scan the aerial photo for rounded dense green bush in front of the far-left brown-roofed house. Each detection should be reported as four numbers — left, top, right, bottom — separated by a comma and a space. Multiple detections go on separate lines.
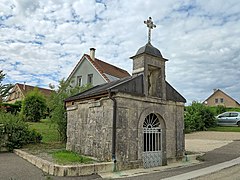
21, 88, 47, 122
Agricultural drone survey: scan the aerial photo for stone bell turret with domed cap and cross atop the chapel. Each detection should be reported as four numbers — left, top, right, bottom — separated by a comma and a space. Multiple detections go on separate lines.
130, 17, 167, 100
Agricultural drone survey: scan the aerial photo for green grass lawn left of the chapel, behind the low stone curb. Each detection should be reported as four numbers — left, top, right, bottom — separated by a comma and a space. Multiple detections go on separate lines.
24, 119, 96, 164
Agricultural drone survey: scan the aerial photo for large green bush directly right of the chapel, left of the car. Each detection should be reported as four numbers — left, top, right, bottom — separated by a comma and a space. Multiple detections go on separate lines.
184, 102, 216, 132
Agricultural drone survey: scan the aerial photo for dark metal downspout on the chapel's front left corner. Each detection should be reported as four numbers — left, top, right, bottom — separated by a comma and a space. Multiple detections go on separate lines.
108, 91, 117, 171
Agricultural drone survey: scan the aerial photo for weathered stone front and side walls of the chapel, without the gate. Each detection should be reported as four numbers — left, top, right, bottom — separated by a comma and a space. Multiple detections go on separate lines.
67, 93, 184, 164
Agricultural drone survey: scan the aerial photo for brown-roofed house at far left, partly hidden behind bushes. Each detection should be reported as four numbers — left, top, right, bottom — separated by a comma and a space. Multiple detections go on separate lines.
6, 83, 53, 103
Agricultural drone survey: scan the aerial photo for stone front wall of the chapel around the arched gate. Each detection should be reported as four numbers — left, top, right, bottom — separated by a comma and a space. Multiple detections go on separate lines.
117, 94, 184, 162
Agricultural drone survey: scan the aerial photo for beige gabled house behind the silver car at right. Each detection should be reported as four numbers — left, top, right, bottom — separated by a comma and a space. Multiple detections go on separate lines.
203, 89, 240, 107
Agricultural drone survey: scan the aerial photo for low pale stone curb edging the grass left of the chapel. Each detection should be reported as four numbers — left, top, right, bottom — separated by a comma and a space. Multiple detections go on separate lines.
14, 149, 114, 176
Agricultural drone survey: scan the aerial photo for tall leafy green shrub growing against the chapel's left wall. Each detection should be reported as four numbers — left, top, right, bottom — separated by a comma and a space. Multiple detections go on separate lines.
48, 79, 92, 142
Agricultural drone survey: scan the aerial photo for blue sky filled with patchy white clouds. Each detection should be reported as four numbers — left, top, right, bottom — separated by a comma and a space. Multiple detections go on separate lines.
0, 0, 240, 103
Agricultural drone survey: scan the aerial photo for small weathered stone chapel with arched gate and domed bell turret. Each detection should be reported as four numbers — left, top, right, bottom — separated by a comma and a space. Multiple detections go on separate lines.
65, 17, 186, 170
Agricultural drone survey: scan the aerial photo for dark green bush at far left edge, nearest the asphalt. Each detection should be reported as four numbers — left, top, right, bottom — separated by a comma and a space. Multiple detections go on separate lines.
0, 111, 42, 151
